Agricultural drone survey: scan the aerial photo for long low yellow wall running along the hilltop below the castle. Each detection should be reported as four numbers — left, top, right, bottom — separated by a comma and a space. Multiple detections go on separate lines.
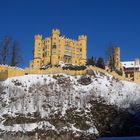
0, 65, 126, 80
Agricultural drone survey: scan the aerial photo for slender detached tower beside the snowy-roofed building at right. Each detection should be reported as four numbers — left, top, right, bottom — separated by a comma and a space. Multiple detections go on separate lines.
114, 47, 121, 70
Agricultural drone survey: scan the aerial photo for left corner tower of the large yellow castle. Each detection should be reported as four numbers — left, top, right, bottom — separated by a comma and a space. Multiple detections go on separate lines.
33, 35, 43, 68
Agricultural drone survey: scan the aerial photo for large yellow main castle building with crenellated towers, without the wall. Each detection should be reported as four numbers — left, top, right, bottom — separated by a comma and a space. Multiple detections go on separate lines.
30, 29, 87, 69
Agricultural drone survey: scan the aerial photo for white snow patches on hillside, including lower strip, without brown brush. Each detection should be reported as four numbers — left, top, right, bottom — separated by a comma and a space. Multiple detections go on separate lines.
0, 72, 140, 134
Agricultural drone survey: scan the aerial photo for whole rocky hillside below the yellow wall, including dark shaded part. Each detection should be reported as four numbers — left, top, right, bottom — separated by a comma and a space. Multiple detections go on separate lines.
0, 72, 140, 140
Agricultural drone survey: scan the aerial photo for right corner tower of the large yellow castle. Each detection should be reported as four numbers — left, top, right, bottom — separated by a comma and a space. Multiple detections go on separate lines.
78, 35, 87, 65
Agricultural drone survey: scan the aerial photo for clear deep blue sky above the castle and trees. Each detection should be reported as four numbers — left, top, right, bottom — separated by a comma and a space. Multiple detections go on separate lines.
0, 0, 140, 67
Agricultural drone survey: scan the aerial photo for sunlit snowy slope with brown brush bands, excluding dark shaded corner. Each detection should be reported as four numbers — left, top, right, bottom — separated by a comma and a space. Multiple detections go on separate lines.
0, 73, 140, 137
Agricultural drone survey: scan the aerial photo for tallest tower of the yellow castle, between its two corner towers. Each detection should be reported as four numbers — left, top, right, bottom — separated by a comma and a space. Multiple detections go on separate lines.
51, 29, 60, 65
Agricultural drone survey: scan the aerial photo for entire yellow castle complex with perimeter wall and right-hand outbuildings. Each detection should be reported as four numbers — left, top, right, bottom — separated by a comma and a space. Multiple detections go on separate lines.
0, 29, 140, 83
